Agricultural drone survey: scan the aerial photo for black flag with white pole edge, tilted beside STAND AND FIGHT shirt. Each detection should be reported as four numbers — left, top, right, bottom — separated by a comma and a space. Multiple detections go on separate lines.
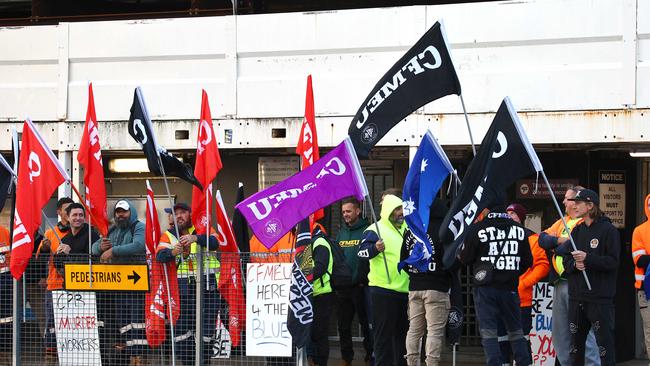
440, 97, 543, 268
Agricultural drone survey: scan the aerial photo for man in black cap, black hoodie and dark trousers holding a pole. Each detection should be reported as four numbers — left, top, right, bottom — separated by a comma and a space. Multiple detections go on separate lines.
563, 189, 621, 366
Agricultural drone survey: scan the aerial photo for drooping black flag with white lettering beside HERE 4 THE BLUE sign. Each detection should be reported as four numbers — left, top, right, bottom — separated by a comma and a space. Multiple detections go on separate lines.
287, 219, 314, 348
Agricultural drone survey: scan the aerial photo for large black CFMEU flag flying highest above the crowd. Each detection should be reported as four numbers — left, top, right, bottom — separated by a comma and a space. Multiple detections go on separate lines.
348, 22, 460, 158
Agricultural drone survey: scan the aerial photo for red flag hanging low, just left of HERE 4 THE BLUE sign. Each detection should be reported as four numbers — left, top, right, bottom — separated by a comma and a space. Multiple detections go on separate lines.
216, 190, 246, 347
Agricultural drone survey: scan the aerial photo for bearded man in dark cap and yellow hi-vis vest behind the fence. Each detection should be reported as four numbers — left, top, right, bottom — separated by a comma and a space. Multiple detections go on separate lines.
156, 203, 221, 365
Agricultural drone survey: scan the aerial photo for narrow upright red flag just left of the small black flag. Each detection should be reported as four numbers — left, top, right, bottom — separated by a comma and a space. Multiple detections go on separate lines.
77, 83, 108, 236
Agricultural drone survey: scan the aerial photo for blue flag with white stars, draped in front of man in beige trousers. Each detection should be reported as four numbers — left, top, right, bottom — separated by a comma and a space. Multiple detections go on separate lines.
398, 131, 455, 272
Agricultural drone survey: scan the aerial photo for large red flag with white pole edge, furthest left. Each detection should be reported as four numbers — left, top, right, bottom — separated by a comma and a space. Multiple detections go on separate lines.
9, 120, 70, 280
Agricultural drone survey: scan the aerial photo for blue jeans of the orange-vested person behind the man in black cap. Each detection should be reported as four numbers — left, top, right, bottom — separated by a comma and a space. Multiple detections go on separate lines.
551, 280, 600, 366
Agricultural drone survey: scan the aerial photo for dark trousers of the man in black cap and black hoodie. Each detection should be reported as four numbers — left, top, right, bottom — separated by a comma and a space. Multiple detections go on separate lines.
569, 299, 616, 366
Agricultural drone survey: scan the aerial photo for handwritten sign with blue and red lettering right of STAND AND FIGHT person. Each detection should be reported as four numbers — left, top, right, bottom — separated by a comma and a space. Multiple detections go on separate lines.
530, 282, 555, 366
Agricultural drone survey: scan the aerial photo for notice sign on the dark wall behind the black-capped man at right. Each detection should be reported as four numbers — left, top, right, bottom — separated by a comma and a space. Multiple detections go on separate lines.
598, 170, 625, 229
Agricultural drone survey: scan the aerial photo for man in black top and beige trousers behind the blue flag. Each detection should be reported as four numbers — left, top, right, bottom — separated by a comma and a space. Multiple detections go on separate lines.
400, 199, 451, 366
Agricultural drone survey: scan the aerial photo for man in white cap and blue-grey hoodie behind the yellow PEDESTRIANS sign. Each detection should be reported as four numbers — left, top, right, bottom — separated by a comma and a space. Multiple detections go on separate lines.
92, 200, 147, 365
